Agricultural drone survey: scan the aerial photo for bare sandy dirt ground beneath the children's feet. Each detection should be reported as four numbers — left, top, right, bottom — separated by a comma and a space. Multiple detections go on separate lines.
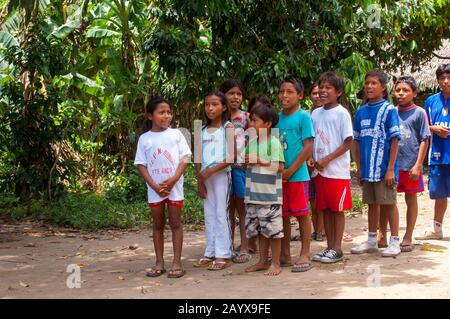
0, 180, 450, 299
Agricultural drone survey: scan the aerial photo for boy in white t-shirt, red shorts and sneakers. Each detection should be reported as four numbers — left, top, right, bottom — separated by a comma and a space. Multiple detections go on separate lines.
311, 72, 353, 263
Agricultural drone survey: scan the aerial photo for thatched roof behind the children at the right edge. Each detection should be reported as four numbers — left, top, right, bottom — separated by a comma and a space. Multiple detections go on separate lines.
395, 40, 450, 91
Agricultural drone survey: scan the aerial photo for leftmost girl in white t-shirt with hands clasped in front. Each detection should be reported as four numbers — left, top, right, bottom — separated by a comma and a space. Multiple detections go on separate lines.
134, 97, 191, 278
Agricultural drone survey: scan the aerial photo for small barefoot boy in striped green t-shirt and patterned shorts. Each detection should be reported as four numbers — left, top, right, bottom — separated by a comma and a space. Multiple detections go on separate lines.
244, 104, 284, 276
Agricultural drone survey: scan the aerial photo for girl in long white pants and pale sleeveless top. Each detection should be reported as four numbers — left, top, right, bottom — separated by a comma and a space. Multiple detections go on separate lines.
194, 91, 235, 270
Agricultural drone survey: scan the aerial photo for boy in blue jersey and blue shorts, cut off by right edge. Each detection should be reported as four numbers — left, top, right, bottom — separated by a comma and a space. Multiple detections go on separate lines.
416, 64, 450, 240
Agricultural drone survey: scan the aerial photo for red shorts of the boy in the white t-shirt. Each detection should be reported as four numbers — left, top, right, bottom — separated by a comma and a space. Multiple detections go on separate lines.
314, 174, 352, 212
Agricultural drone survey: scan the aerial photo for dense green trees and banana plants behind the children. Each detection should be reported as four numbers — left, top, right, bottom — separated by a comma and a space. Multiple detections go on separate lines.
0, 0, 450, 227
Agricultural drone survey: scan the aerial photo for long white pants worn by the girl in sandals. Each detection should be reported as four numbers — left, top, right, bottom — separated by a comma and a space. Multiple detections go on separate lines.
203, 170, 233, 259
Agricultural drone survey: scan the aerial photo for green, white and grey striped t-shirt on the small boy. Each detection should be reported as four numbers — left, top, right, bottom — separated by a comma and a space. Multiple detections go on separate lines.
244, 136, 284, 205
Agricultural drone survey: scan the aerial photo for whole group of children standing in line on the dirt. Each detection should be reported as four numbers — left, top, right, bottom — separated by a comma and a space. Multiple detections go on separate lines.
135, 64, 450, 278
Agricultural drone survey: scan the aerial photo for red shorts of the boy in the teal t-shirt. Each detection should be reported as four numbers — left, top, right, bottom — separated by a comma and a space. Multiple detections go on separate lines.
282, 182, 309, 216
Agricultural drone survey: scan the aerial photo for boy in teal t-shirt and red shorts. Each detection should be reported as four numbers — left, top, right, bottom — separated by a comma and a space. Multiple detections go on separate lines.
276, 78, 314, 272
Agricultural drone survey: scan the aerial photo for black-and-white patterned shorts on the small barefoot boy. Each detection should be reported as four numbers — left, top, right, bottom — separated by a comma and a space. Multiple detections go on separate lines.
245, 204, 284, 239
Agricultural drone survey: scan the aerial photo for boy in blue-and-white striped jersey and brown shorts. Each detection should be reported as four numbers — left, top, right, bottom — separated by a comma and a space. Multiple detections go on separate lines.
351, 70, 400, 257
